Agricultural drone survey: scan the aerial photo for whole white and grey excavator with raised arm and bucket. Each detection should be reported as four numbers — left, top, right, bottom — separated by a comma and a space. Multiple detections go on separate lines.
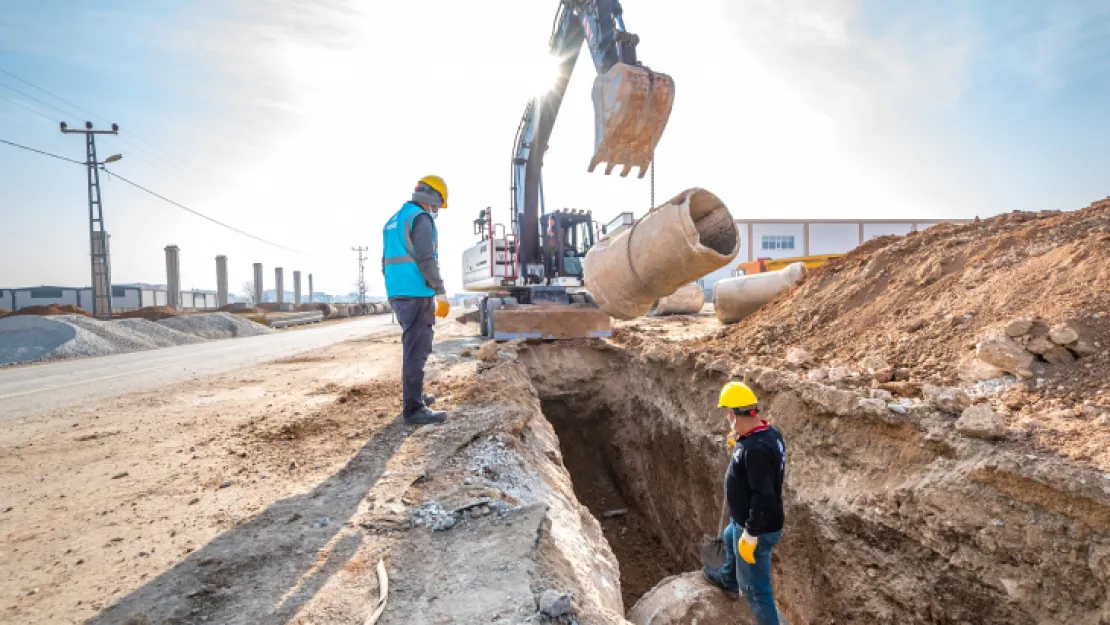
463, 0, 675, 341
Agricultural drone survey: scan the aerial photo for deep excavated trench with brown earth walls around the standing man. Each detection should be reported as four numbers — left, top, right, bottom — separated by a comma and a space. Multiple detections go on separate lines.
519, 344, 1110, 625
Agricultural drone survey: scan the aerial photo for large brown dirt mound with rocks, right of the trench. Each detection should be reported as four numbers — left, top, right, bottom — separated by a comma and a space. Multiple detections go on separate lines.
674, 200, 1110, 462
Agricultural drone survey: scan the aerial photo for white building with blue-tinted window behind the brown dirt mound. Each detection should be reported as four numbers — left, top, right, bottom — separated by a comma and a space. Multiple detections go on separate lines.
698, 219, 971, 296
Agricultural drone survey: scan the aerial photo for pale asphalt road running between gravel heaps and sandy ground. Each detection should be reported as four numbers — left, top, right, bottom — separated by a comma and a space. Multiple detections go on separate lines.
0, 315, 396, 421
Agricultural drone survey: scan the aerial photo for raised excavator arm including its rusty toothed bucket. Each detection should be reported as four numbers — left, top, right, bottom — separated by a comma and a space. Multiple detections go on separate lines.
512, 0, 675, 280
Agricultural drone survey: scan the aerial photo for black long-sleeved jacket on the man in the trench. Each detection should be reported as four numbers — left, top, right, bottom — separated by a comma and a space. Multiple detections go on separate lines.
725, 425, 786, 536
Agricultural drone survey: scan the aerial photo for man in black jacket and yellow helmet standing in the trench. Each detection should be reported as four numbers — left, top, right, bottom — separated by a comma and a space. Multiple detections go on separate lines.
703, 382, 786, 625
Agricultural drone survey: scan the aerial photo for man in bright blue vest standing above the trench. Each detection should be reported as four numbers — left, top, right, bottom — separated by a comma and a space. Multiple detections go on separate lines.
382, 175, 451, 425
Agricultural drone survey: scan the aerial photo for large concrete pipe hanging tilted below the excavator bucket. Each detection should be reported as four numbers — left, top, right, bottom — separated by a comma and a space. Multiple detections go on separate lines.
583, 189, 740, 320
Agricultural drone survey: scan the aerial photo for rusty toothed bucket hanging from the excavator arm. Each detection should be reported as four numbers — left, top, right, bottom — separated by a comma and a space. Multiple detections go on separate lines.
587, 63, 675, 178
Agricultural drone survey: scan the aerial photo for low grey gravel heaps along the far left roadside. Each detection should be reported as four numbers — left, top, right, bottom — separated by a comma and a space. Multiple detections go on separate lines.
0, 313, 273, 366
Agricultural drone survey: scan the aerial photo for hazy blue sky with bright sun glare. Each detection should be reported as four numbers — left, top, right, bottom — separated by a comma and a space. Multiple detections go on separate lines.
0, 0, 1110, 294
